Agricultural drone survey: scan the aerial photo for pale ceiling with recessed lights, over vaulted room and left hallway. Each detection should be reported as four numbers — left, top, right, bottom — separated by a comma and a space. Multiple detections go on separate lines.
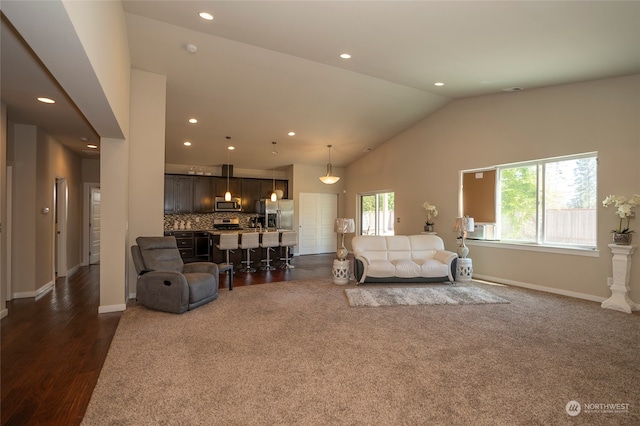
1, 1, 640, 169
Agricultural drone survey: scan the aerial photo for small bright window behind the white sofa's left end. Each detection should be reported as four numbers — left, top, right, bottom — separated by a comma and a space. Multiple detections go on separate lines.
360, 192, 394, 235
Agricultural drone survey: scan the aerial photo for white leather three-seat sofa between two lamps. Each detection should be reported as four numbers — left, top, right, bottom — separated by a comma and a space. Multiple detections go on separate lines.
351, 234, 458, 284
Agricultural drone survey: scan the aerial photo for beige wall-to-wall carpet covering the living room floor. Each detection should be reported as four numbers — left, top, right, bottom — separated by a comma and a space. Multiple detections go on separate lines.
83, 279, 640, 426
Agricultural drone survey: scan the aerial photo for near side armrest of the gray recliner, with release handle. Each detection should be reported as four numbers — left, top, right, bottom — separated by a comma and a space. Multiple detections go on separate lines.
136, 271, 189, 313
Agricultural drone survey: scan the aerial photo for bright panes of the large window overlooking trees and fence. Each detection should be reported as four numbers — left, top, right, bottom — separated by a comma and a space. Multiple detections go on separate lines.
463, 153, 598, 248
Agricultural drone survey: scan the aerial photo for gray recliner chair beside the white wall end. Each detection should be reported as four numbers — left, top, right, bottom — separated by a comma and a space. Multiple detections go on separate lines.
131, 236, 219, 314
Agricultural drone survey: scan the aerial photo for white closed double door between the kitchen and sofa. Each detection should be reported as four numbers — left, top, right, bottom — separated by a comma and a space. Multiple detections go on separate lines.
298, 193, 338, 254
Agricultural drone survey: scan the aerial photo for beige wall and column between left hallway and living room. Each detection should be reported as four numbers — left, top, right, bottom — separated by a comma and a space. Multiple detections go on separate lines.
2, 0, 131, 312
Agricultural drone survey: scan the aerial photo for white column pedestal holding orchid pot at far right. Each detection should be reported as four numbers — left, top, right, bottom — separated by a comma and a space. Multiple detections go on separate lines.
601, 244, 640, 314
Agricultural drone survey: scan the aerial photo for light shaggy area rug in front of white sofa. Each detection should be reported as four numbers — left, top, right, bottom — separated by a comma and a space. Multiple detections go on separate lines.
344, 286, 509, 307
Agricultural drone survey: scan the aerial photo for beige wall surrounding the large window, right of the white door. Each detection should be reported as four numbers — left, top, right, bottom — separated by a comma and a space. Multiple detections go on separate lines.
346, 75, 640, 300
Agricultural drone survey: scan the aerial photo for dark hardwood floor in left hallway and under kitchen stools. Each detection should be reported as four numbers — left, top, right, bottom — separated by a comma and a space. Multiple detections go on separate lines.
0, 254, 335, 426
